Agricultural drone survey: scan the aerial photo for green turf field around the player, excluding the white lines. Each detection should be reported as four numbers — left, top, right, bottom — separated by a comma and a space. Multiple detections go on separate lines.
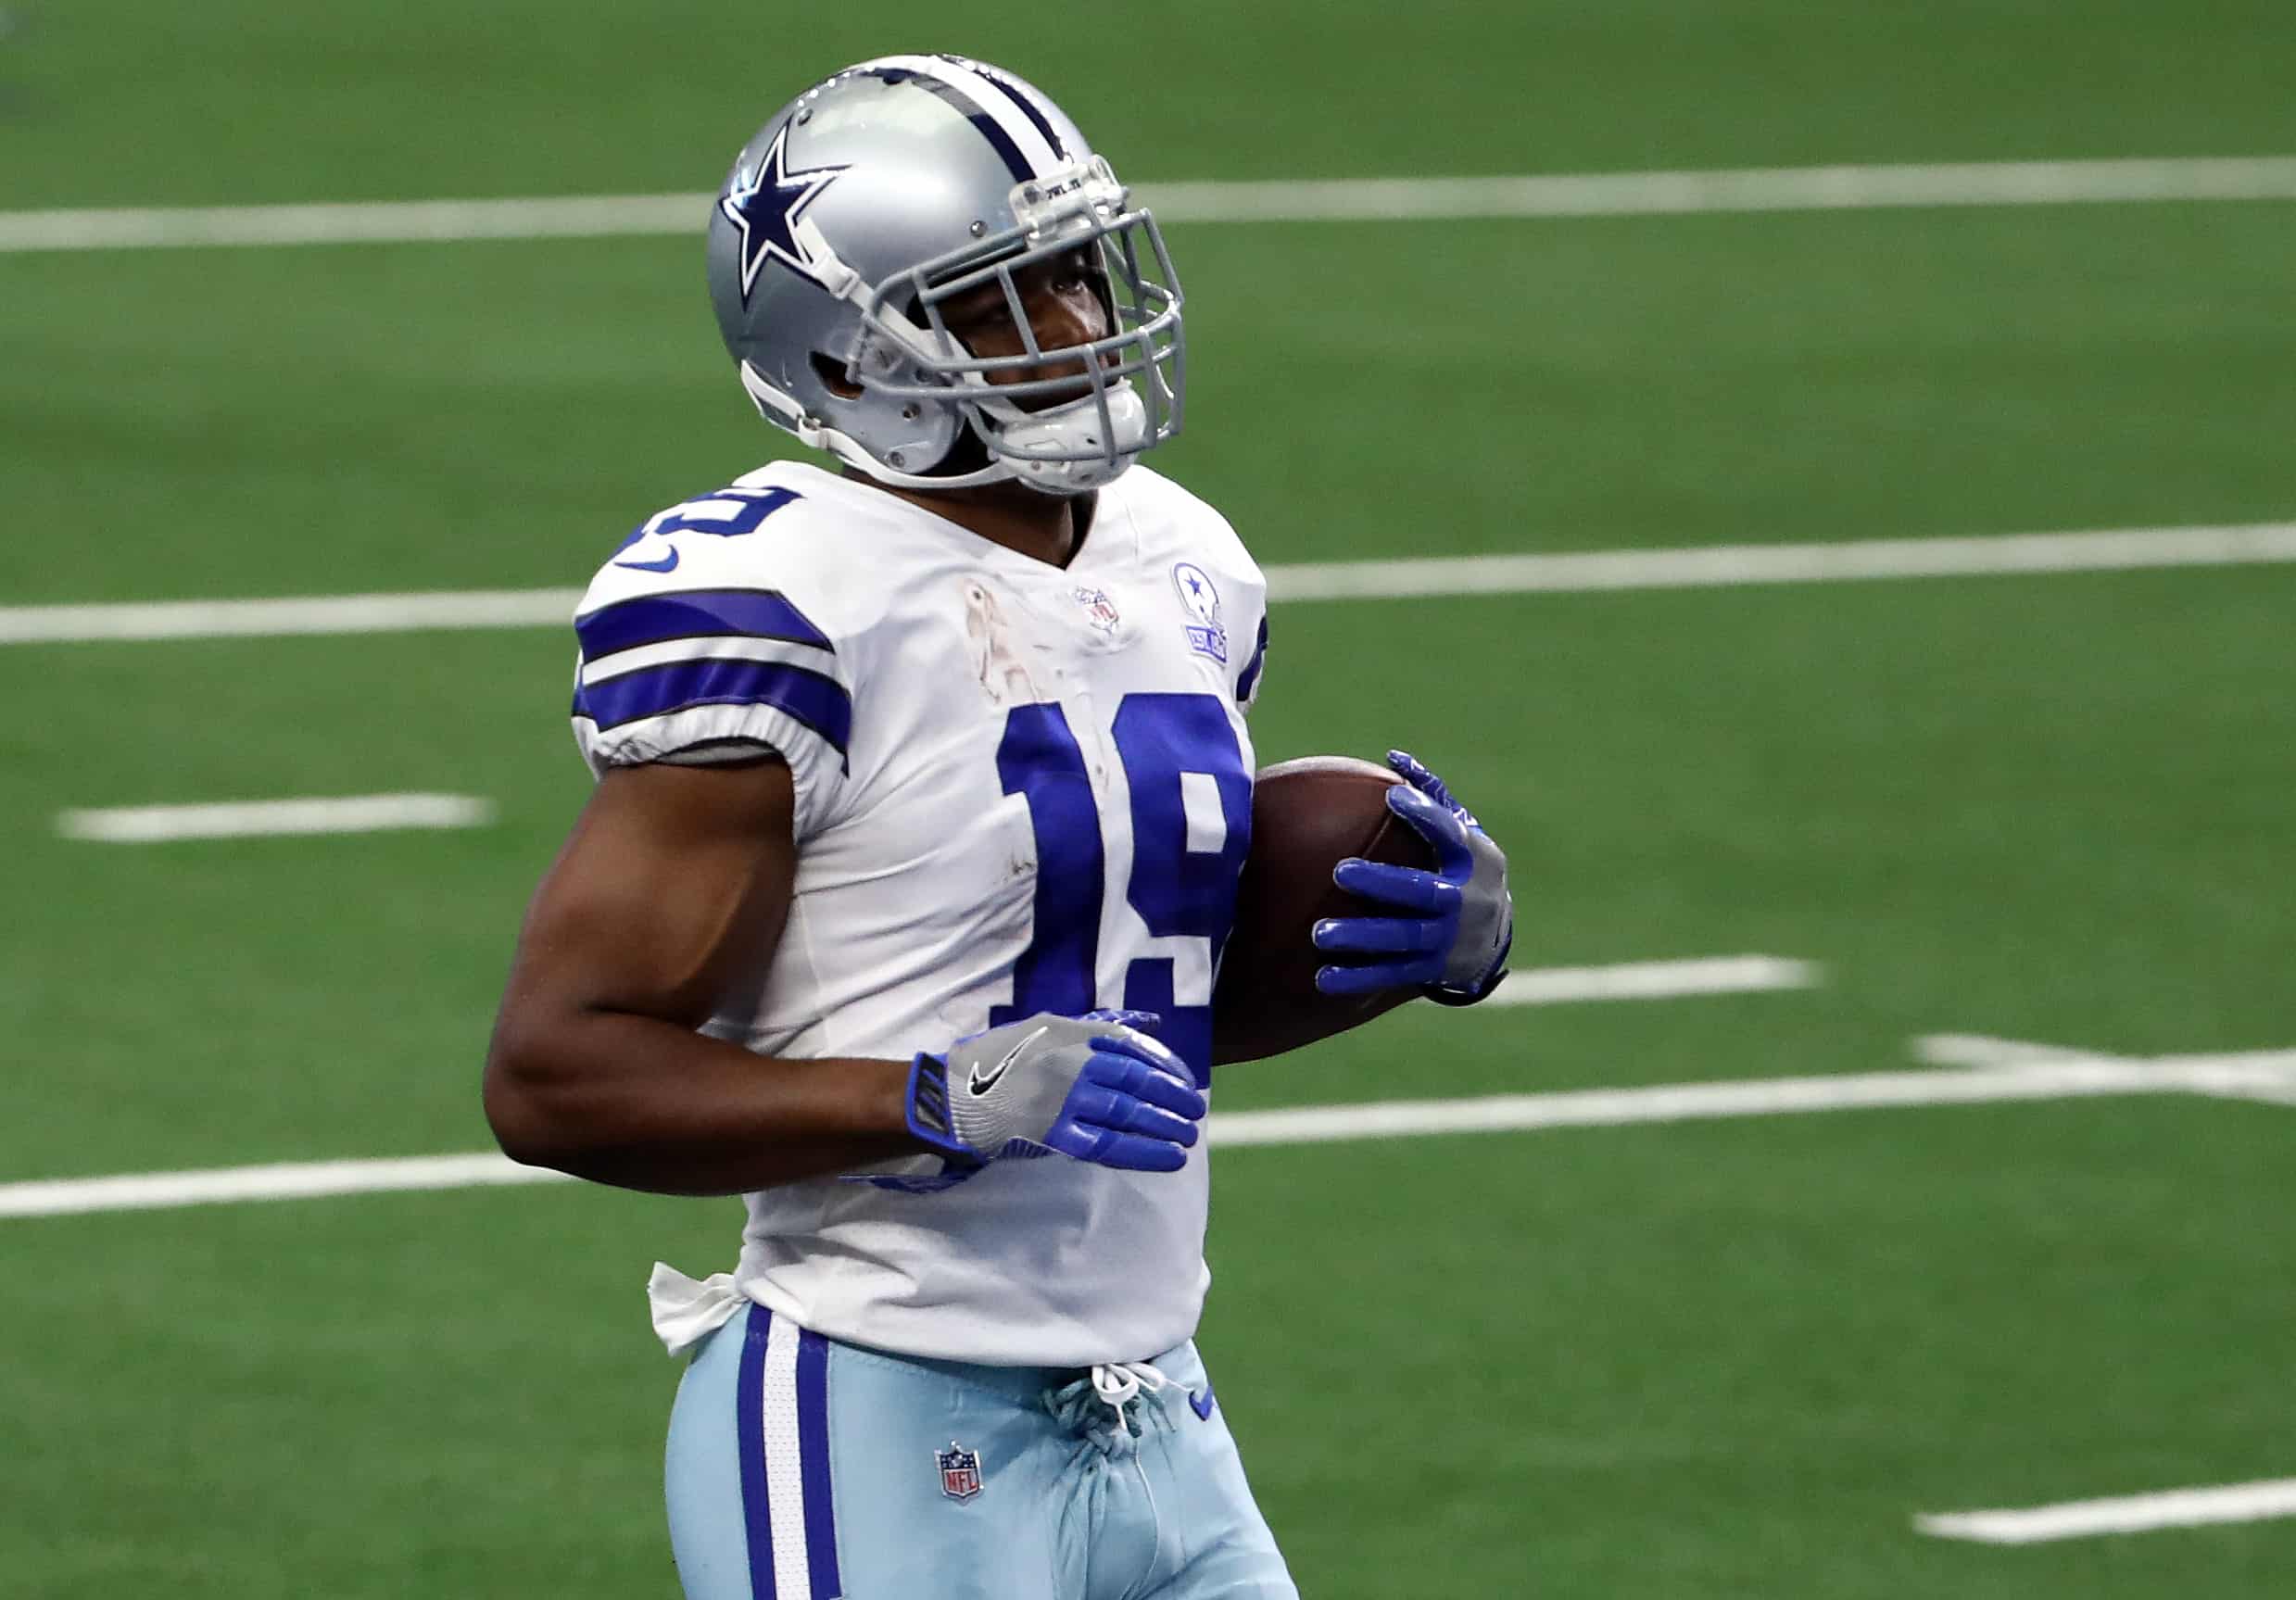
0, 0, 2296, 1600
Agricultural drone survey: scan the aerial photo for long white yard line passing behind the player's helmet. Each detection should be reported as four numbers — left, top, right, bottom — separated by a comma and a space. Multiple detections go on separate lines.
0, 156, 2296, 253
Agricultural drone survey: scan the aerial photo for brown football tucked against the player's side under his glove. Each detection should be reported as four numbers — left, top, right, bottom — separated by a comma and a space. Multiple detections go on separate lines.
1212, 755, 1435, 1061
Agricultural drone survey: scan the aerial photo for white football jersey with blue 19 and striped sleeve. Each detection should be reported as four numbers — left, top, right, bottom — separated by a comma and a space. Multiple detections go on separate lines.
574, 461, 1268, 1366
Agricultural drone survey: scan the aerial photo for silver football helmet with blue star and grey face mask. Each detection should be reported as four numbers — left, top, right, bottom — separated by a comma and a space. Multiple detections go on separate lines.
710, 55, 1182, 494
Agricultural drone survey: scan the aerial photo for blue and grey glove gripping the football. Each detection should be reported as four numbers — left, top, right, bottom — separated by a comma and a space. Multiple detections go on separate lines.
1313, 750, 1515, 1005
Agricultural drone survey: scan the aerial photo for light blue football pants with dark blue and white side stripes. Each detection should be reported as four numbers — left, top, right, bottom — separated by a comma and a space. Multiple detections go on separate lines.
666, 1306, 1300, 1600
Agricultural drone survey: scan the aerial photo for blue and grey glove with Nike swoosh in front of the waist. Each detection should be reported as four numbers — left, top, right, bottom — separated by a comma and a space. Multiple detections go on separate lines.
909, 1010, 1205, 1173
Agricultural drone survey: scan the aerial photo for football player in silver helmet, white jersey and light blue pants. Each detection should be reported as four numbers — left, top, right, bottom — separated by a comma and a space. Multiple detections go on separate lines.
486, 55, 1513, 1600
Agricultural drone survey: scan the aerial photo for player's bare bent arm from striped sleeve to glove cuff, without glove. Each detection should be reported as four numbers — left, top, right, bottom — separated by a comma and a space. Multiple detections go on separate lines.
486, 760, 918, 1193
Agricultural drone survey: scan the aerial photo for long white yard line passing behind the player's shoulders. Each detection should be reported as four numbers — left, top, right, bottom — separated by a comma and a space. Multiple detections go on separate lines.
0, 523, 2296, 645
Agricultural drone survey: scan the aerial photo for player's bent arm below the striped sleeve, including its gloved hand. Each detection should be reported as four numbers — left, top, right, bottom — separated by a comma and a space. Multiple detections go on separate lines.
486, 760, 1205, 1193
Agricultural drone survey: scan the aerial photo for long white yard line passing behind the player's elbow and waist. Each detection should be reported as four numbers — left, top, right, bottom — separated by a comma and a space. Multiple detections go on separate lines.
0, 1052, 2296, 1216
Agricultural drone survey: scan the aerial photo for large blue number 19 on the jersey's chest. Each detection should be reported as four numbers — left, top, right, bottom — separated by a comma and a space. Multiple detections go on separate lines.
990, 693, 1252, 1084
